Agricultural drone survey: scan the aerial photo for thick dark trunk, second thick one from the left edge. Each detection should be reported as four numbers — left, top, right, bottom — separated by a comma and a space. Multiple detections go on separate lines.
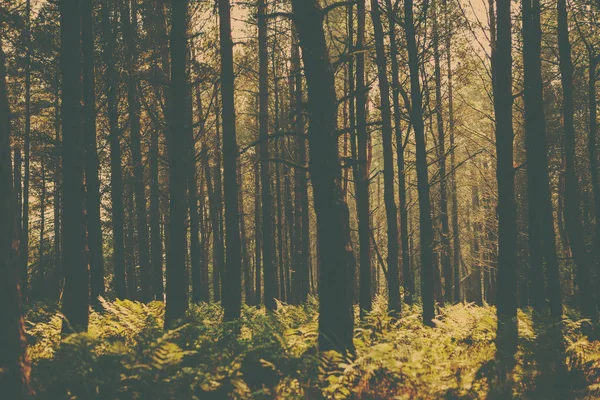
59, 0, 90, 333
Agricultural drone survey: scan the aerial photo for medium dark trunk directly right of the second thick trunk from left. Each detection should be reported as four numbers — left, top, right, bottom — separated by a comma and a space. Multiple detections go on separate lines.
81, 0, 104, 309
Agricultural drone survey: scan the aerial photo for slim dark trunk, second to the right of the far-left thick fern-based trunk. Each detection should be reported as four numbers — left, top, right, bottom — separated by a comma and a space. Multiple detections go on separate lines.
102, 4, 127, 299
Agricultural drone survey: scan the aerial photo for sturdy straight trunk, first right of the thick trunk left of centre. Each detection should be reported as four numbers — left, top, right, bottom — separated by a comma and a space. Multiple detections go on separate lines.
219, 0, 242, 320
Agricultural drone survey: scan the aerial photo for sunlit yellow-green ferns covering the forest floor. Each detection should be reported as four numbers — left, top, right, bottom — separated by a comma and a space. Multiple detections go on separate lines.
26, 297, 600, 400
